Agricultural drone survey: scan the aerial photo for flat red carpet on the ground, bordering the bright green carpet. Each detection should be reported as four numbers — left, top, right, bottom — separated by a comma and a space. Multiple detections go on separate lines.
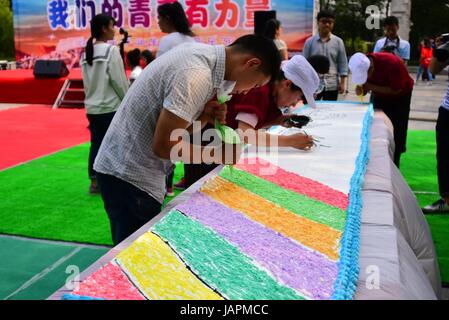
0, 106, 90, 170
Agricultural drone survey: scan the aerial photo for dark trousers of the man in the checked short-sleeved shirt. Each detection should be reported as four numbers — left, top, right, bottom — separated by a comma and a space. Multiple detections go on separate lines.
97, 173, 161, 245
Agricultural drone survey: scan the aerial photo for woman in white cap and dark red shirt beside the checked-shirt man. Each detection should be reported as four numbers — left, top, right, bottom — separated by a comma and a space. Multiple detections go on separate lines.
226, 55, 320, 150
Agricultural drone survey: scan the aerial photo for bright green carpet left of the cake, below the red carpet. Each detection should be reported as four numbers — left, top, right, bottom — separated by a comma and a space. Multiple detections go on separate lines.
0, 144, 184, 245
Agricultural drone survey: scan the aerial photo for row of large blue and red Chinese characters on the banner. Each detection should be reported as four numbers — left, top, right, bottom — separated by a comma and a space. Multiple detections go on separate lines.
47, 0, 271, 30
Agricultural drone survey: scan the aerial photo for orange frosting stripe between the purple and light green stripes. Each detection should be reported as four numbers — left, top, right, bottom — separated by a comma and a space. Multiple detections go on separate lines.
201, 176, 341, 260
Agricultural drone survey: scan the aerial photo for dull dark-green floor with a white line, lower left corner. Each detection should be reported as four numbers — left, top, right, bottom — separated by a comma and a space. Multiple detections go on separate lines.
0, 237, 107, 300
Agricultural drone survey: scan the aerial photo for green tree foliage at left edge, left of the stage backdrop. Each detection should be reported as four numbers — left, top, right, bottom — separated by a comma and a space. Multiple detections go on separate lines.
0, 0, 14, 59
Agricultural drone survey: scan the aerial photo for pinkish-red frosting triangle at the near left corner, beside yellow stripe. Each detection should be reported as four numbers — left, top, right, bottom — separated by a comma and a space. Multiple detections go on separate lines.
73, 263, 146, 300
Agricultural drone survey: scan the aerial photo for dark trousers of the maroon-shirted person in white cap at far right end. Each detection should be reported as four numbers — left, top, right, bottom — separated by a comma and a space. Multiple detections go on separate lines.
373, 92, 412, 168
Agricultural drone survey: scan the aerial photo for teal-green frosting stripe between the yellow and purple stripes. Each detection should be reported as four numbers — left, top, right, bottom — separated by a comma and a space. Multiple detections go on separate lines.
152, 211, 304, 300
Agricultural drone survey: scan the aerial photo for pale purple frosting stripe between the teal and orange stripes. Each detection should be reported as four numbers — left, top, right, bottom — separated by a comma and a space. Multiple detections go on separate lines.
176, 192, 338, 299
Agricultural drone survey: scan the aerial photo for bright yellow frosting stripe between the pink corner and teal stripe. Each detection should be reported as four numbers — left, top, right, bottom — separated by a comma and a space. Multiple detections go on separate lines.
116, 232, 223, 300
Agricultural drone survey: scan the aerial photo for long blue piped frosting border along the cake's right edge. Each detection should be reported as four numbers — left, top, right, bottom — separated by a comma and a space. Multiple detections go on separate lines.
332, 104, 374, 300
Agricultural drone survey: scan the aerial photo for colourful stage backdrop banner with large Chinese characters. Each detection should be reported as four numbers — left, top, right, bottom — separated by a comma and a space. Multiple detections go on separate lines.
12, 0, 314, 68
